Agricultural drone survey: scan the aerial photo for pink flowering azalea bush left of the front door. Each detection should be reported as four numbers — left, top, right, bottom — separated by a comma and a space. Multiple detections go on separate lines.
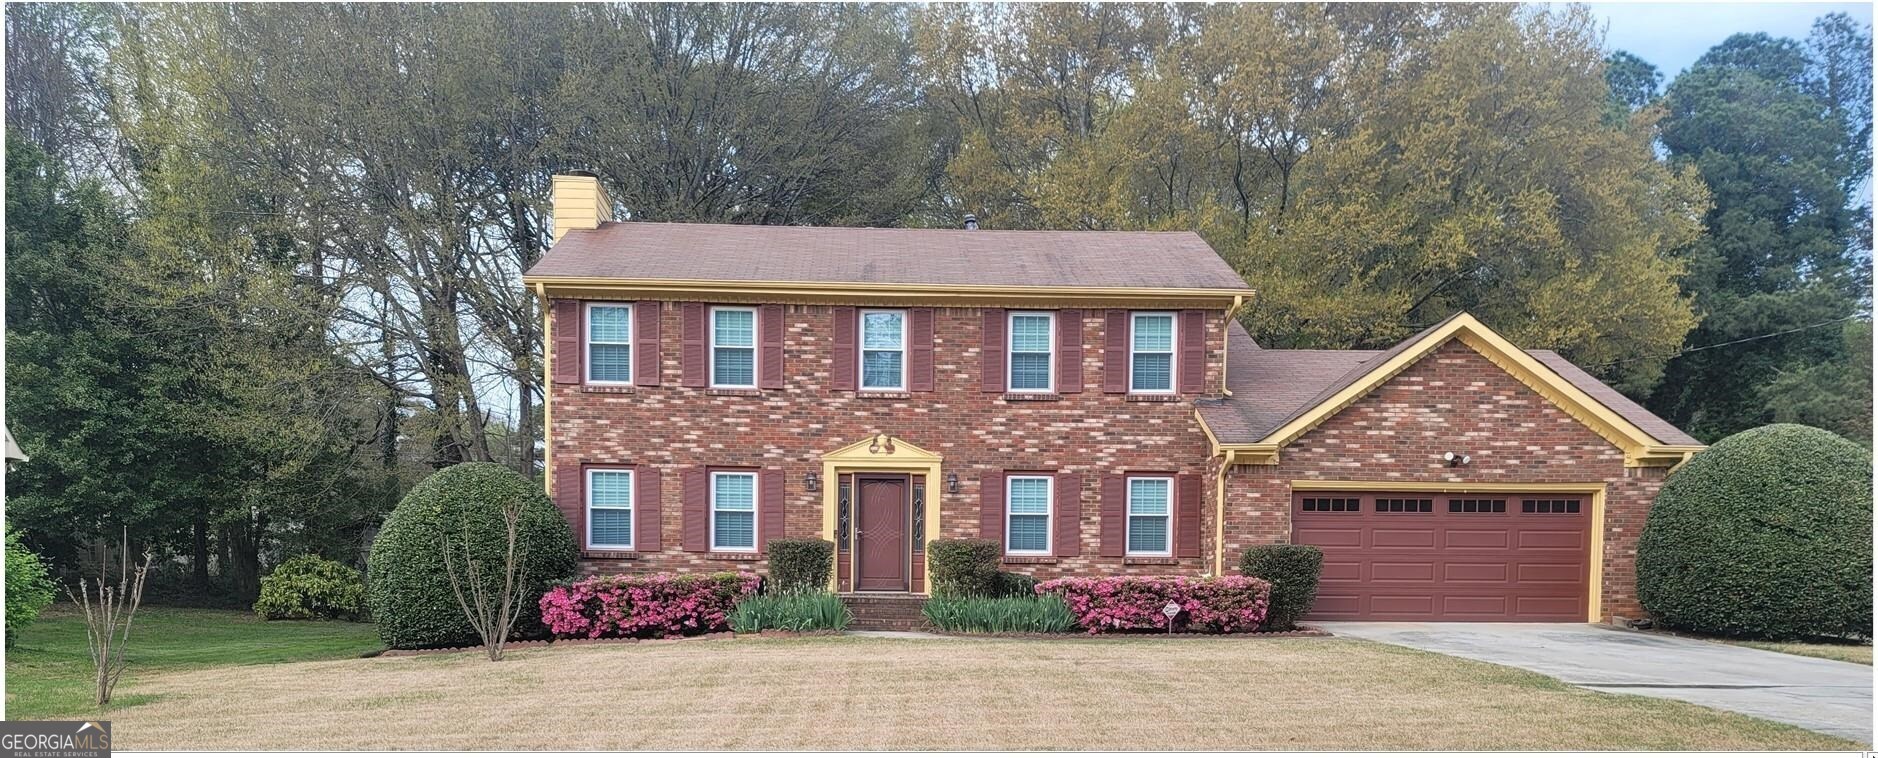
541, 572, 762, 640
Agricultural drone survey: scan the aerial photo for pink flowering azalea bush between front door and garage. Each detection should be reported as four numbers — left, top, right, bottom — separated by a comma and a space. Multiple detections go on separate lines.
1037, 576, 1271, 634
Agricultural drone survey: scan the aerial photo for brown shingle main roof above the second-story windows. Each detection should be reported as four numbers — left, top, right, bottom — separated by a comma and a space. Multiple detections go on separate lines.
528, 221, 1251, 293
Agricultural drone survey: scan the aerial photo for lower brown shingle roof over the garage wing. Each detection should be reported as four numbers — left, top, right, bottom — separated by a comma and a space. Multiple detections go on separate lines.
1200, 319, 1701, 445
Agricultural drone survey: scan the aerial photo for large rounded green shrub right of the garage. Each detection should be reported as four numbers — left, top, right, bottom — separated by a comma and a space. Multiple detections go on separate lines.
1638, 424, 1872, 640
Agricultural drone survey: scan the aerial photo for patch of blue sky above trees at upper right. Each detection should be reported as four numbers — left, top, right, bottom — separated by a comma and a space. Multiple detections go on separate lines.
1587, 2, 1872, 76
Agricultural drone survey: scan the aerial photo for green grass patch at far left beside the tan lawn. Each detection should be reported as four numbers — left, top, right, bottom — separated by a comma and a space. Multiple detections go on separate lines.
6, 604, 383, 720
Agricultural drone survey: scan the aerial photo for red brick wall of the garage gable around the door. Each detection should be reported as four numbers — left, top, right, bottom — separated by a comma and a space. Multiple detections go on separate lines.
1224, 341, 1664, 617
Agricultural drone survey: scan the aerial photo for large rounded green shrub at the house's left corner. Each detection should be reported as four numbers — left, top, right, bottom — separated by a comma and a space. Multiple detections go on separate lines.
366, 463, 575, 649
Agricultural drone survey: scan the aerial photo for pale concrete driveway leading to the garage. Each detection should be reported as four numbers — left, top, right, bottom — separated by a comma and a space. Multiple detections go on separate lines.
1315, 621, 1872, 745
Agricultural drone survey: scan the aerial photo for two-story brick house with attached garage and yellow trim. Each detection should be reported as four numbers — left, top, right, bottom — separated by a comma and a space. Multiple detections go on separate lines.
524, 176, 1701, 621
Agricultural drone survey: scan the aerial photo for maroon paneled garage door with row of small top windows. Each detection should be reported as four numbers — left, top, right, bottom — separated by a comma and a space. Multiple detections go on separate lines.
1292, 492, 1591, 621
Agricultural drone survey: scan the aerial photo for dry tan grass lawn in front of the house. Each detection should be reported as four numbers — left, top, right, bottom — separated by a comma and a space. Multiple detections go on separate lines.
88, 638, 1855, 750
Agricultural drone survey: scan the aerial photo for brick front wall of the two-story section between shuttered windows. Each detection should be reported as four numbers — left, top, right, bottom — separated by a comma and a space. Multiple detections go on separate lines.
550, 304, 1224, 578
